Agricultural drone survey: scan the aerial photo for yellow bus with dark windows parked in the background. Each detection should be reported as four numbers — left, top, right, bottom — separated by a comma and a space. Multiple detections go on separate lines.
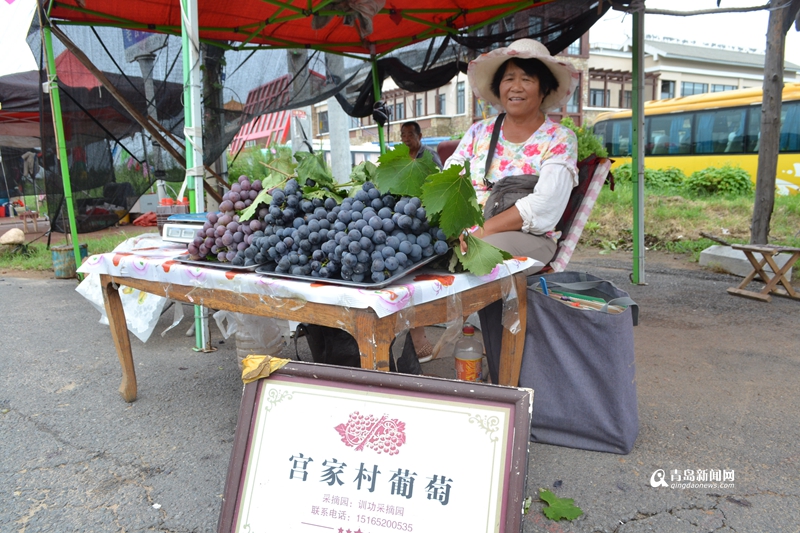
594, 83, 800, 194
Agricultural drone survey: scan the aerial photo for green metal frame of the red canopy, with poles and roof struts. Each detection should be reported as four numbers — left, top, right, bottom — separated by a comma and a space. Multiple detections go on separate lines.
40, 0, 644, 351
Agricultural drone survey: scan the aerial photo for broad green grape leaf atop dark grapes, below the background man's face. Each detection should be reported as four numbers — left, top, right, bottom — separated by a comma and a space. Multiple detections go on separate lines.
374, 144, 439, 196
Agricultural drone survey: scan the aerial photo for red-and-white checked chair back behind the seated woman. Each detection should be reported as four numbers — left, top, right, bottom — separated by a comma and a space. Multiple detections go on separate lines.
541, 156, 614, 273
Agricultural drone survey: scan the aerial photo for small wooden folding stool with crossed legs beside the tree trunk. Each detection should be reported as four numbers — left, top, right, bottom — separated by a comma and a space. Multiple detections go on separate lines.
728, 244, 800, 302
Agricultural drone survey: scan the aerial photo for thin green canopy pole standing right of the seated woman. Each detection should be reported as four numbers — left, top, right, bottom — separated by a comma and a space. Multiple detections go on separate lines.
631, 6, 646, 285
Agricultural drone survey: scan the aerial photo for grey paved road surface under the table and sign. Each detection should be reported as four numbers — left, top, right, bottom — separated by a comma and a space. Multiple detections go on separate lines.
0, 256, 800, 533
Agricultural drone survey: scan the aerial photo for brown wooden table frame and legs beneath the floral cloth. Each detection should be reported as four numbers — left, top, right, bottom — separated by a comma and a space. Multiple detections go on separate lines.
100, 271, 527, 402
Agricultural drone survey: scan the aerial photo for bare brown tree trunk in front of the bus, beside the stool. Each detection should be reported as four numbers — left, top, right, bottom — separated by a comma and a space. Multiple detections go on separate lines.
750, 0, 800, 244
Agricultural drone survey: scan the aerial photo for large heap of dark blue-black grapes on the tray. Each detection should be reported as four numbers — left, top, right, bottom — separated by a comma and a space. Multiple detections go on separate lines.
189, 179, 449, 283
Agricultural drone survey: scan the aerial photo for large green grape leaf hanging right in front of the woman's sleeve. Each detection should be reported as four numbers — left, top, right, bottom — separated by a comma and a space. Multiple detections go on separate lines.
420, 165, 483, 237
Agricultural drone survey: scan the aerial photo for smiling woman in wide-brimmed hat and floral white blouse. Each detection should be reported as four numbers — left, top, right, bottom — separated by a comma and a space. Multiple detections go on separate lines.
445, 39, 578, 273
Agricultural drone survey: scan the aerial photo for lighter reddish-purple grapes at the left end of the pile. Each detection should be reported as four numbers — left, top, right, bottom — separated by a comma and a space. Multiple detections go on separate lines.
188, 175, 262, 262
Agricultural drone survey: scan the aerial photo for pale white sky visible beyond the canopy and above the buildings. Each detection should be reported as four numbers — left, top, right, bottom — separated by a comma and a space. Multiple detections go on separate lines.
0, 0, 800, 76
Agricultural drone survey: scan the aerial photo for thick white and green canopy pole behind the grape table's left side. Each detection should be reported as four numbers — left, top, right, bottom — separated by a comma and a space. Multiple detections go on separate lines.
181, 0, 213, 352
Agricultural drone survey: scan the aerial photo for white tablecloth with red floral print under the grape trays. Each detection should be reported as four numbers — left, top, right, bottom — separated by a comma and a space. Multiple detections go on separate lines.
78, 235, 540, 318
